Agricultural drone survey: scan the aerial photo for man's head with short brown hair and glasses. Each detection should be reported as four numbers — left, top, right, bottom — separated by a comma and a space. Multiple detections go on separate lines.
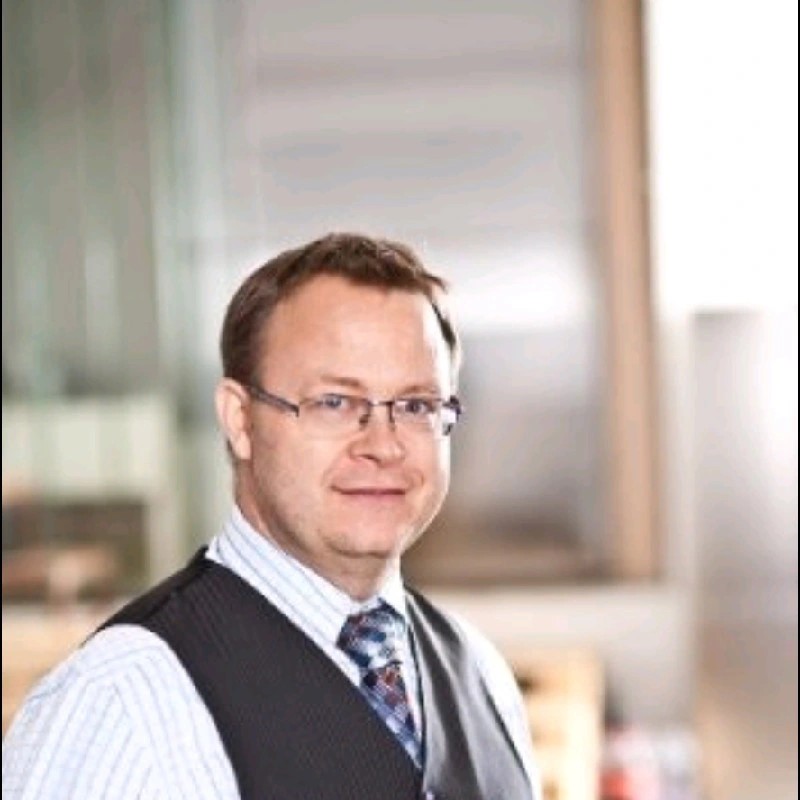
217, 234, 459, 596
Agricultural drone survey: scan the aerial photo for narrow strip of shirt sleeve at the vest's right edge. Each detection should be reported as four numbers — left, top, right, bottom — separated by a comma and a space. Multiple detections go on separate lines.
455, 615, 542, 800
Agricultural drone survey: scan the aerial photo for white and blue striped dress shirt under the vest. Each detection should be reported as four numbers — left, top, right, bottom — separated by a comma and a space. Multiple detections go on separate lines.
3, 508, 538, 800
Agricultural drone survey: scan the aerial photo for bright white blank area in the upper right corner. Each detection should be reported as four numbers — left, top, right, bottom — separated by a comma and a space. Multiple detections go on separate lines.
647, 0, 797, 315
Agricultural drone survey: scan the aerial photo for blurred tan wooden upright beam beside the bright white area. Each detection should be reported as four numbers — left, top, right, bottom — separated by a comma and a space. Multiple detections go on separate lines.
592, 0, 660, 580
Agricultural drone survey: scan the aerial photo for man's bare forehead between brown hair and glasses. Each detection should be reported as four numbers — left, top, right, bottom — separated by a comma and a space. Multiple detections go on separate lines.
262, 275, 450, 385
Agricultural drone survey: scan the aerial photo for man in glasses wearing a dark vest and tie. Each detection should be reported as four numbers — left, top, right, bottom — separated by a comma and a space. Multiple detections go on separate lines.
3, 234, 539, 800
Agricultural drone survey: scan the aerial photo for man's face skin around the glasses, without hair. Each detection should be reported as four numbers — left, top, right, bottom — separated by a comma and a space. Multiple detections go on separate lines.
225, 276, 453, 585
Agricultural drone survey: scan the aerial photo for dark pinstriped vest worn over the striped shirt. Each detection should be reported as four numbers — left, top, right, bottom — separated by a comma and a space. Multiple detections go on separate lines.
103, 551, 531, 800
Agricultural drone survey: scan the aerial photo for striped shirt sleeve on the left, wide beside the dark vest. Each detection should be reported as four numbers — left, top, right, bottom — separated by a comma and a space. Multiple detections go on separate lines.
3, 626, 238, 800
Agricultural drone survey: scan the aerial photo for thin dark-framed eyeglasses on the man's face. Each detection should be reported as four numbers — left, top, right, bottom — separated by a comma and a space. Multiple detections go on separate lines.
244, 384, 463, 438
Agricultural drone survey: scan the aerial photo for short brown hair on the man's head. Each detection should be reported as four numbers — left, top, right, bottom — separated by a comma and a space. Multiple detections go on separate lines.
220, 233, 460, 384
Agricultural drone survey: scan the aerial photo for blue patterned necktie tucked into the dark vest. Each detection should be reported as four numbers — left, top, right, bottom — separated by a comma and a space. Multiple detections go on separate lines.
337, 603, 421, 766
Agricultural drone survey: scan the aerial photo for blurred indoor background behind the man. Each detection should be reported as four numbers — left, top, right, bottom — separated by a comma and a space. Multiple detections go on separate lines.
2, 0, 798, 800
